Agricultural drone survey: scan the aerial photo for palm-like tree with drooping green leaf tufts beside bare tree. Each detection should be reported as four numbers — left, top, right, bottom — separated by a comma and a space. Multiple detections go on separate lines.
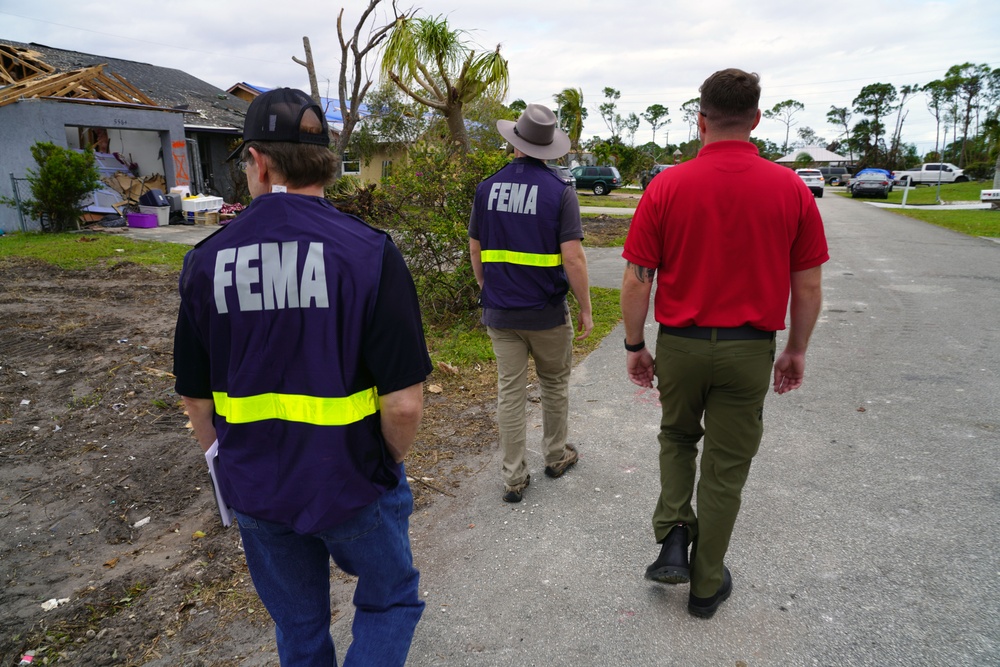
382, 16, 509, 153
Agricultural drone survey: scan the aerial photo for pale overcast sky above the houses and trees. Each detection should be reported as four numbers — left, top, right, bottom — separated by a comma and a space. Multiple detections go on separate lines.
0, 0, 1000, 153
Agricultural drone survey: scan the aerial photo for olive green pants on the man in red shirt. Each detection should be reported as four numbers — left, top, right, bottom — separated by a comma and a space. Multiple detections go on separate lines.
653, 333, 775, 597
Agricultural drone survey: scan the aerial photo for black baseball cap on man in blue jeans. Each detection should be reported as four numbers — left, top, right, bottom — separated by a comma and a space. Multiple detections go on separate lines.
226, 88, 330, 162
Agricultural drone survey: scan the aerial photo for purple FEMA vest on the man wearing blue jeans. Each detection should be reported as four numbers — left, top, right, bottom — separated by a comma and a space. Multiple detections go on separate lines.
181, 194, 401, 533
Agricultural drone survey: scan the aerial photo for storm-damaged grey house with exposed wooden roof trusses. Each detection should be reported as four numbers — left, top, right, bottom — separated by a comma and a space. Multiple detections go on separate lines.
0, 40, 248, 231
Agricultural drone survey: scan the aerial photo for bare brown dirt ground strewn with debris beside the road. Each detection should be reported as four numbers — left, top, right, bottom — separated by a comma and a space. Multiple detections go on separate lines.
0, 217, 627, 666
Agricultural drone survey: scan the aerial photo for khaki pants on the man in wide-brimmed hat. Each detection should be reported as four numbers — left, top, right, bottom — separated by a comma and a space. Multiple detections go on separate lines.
486, 319, 573, 488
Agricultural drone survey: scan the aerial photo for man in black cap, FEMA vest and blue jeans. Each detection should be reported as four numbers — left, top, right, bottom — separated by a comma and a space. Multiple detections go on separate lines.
174, 88, 431, 667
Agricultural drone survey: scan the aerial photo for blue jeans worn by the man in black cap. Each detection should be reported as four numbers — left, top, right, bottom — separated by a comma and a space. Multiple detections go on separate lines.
236, 477, 424, 667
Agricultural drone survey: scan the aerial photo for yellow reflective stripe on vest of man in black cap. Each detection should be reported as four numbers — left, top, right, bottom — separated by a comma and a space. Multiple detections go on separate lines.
212, 388, 378, 426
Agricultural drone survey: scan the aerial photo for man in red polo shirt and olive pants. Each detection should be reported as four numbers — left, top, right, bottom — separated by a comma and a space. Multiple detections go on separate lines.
621, 69, 829, 618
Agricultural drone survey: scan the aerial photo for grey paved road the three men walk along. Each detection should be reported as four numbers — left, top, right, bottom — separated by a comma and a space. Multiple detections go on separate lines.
384, 197, 1000, 667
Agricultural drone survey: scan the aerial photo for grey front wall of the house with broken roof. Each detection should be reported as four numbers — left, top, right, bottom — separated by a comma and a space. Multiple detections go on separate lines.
0, 99, 187, 232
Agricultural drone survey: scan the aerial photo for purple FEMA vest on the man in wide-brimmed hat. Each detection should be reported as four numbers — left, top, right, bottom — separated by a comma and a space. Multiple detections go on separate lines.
474, 159, 569, 310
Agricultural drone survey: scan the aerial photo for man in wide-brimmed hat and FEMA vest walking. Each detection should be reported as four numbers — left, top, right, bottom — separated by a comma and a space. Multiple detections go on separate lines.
469, 104, 594, 503
